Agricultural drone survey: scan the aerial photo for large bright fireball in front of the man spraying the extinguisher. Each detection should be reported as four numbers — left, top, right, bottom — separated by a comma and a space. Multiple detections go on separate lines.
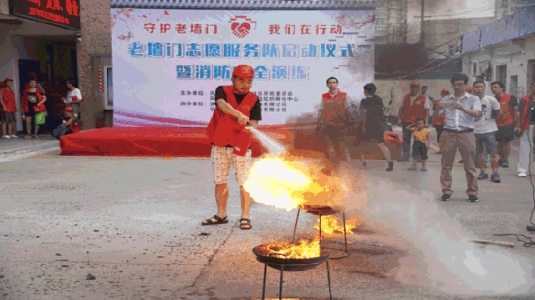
243, 156, 350, 211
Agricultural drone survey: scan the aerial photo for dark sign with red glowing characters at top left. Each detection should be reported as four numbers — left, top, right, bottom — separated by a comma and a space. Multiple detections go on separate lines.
12, 0, 80, 30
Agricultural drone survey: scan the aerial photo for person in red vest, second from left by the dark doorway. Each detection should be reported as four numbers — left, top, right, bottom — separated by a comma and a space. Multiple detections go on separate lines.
22, 79, 46, 139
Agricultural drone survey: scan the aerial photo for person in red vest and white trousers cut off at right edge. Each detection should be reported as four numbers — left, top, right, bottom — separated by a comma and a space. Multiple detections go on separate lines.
516, 82, 535, 177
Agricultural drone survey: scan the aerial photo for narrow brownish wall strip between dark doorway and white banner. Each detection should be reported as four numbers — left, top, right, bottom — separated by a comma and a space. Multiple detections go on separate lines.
76, 0, 113, 128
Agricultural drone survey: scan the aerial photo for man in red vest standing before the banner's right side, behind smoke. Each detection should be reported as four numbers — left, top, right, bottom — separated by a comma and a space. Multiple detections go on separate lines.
316, 77, 351, 166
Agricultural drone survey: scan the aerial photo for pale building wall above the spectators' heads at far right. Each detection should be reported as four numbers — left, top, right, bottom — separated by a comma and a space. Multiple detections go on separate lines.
463, 37, 535, 95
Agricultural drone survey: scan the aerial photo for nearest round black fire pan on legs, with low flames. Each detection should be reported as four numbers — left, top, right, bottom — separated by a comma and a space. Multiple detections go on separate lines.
253, 243, 332, 300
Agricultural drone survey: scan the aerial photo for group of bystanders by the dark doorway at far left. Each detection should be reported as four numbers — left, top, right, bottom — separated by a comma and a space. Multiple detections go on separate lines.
0, 72, 83, 139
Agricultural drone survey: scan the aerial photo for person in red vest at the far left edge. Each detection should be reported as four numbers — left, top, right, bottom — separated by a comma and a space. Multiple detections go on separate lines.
0, 78, 17, 139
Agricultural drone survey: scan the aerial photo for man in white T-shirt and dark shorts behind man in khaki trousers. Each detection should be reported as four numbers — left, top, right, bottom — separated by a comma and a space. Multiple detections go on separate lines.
473, 81, 502, 182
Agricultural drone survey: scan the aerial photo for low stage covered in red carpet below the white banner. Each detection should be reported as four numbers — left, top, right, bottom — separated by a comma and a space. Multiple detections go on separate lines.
60, 127, 399, 159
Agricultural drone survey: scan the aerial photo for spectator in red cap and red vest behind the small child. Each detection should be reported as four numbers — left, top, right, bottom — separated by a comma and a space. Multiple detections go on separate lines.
397, 81, 430, 161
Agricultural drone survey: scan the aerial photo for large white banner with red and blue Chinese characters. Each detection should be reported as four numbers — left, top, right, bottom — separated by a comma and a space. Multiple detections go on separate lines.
111, 8, 375, 127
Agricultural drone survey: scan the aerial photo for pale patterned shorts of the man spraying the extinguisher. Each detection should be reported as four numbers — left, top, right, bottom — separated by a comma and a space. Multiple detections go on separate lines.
211, 146, 252, 186
